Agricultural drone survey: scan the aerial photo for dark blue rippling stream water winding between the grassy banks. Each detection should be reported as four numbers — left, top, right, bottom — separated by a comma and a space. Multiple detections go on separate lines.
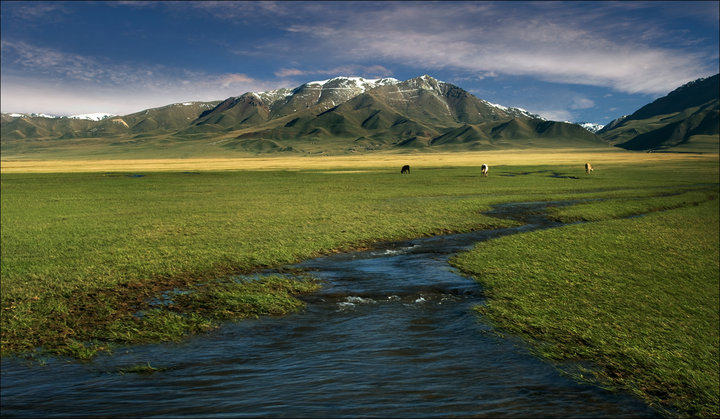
1, 204, 658, 418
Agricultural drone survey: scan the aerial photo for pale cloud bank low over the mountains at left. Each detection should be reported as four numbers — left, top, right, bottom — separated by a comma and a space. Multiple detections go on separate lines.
1, 40, 281, 115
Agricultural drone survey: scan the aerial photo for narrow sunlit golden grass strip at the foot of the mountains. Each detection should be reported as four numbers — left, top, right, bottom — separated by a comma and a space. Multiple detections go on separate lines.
0, 149, 718, 173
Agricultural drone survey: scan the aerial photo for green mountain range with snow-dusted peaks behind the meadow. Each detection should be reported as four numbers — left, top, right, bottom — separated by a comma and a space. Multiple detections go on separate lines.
1, 75, 718, 157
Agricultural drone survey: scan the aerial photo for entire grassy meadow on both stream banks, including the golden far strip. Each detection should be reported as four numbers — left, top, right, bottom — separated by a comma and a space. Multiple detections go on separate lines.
0, 150, 720, 416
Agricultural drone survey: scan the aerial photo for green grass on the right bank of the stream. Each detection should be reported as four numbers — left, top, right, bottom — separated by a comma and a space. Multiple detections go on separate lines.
452, 168, 720, 417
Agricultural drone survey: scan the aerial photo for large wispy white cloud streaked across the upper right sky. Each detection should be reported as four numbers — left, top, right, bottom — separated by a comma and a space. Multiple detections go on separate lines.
268, 2, 717, 94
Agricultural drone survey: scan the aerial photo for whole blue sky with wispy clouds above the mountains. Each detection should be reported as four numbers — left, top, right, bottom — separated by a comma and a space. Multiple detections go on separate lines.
0, 1, 720, 124
